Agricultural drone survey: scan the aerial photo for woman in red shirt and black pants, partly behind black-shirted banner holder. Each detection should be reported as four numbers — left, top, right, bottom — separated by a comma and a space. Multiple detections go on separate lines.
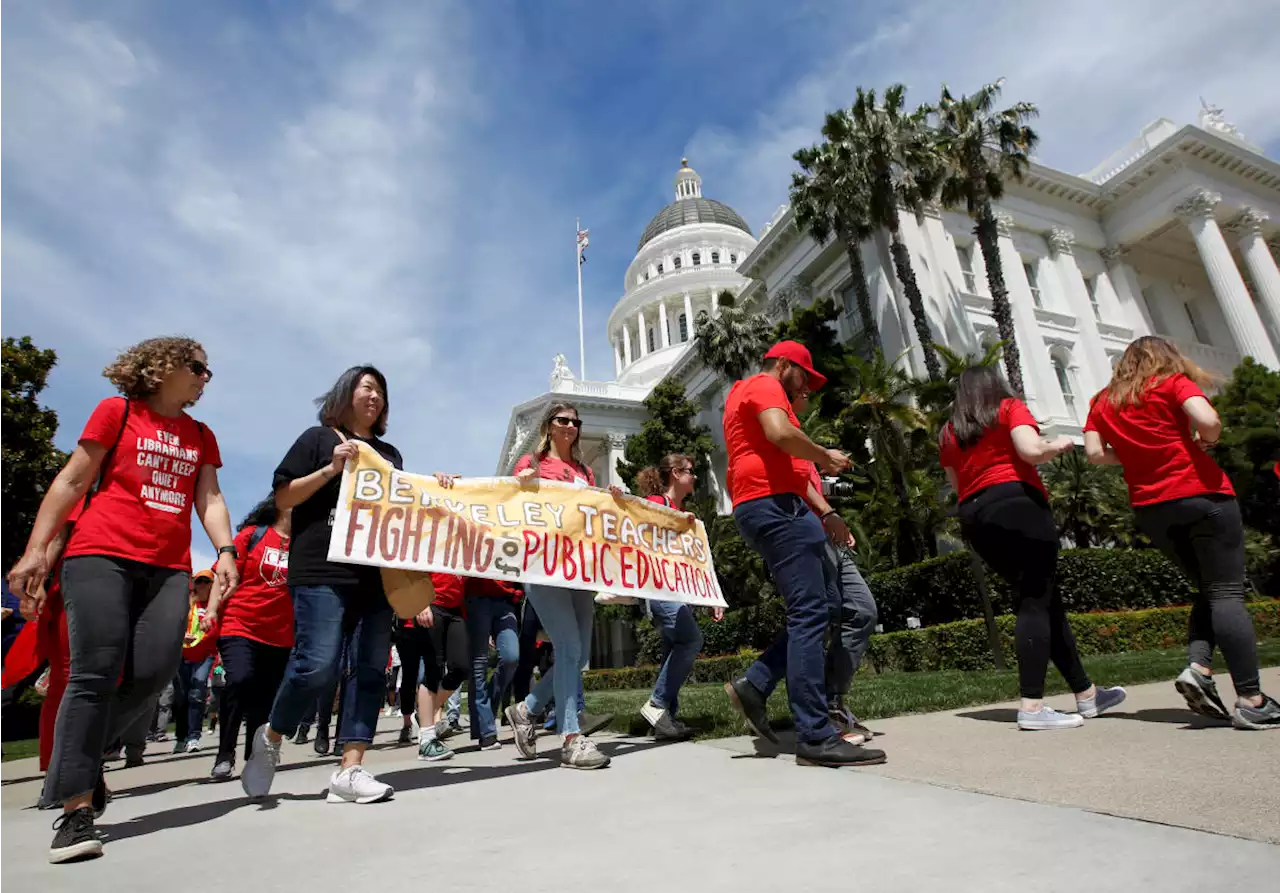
205, 495, 293, 782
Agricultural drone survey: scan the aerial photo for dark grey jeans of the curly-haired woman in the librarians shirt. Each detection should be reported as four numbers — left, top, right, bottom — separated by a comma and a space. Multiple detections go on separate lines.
44, 555, 189, 803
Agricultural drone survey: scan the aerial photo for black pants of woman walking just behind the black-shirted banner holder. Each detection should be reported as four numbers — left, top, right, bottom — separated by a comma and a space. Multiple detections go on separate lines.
218, 636, 291, 763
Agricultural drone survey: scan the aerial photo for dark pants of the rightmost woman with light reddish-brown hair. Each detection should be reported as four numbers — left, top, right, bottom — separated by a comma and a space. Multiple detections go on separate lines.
1134, 494, 1261, 697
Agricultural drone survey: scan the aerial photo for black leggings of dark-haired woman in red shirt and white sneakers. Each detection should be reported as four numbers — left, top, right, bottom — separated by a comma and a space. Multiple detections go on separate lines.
960, 484, 1092, 701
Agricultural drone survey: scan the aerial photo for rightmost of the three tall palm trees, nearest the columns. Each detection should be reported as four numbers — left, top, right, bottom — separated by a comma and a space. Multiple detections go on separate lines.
931, 78, 1039, 394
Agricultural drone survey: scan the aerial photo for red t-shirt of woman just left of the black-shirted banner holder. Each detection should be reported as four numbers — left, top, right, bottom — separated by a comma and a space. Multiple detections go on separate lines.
219, 527, 293, 649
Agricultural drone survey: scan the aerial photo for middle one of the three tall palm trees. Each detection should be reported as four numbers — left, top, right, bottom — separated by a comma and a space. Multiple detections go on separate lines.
839, 83, 942, 380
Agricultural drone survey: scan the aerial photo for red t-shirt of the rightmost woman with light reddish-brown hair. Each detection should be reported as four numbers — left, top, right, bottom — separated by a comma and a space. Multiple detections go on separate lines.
1084, 372, 1235, 505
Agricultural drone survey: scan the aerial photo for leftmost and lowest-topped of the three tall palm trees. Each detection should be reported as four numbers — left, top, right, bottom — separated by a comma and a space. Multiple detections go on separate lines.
791, 135, 882, 352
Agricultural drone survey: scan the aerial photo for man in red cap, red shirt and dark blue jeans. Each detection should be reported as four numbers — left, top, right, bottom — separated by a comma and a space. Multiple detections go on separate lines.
724, 342, 884, 766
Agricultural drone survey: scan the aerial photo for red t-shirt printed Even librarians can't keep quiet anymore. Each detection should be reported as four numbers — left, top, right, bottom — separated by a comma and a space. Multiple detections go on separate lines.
65, 398, 223, 571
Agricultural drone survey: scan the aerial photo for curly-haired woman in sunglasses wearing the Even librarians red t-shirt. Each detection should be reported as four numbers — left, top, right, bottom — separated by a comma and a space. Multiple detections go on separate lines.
9, 338, 239, 862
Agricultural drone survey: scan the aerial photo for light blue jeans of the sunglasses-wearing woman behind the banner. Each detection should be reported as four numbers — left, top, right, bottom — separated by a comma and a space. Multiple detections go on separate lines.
525, 583, 595, 736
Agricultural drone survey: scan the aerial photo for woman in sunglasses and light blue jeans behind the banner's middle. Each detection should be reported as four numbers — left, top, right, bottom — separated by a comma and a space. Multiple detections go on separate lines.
507, 403, 609, 769
